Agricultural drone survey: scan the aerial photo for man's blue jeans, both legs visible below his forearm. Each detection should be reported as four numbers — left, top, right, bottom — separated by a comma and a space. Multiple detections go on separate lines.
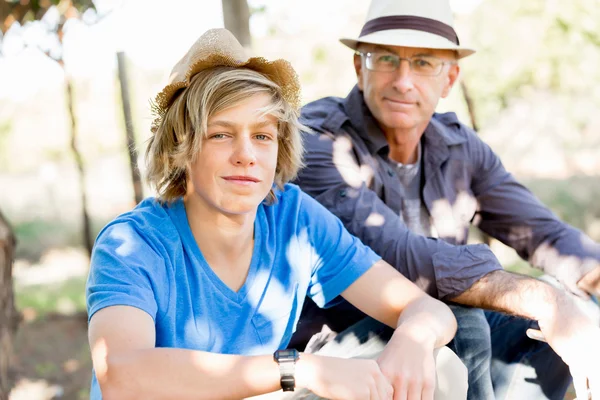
448, 305, 571, 400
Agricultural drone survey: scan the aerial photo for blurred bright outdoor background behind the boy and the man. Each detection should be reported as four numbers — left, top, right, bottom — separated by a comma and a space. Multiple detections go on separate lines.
0, 0, 600, 400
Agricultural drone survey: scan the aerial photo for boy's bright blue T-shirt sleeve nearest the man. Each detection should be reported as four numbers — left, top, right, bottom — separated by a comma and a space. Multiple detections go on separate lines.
302, 193, 381, 308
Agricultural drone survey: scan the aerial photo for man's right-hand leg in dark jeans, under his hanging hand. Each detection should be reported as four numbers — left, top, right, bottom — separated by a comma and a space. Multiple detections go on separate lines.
485, 311, 571, 400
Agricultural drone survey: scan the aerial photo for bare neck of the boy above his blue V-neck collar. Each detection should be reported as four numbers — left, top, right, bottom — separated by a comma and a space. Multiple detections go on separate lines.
184, 197, 256, 266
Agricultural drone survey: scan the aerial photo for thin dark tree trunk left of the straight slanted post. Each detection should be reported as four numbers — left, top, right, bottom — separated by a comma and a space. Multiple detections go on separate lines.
61, 76, 93, 255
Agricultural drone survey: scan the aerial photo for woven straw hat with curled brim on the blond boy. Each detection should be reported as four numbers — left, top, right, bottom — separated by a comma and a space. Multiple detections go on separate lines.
153, 28, 300, 116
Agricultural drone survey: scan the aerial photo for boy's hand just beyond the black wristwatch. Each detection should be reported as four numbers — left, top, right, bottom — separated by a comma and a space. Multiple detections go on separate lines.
296, 353, 393, 400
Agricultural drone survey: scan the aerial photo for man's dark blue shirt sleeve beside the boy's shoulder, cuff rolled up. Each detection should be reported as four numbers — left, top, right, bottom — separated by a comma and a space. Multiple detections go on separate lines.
296, 129, 502, 299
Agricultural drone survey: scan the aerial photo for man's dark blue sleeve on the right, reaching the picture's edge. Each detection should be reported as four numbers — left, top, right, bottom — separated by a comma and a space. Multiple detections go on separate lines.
463, 127, 600, 294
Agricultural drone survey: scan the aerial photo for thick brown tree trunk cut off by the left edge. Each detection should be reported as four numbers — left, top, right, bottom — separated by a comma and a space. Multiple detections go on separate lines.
0, 208, 18, 400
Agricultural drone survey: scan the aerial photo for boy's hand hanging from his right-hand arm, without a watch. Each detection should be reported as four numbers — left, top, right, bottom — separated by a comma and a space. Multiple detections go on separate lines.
377, 321, 436, 400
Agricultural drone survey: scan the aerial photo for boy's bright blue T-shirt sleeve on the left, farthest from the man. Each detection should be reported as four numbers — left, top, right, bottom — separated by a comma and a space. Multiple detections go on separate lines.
86, 222, 169, 321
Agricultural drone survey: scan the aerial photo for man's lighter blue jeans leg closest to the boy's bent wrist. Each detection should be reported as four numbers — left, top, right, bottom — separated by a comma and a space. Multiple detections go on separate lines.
448, 305, 495, 400
